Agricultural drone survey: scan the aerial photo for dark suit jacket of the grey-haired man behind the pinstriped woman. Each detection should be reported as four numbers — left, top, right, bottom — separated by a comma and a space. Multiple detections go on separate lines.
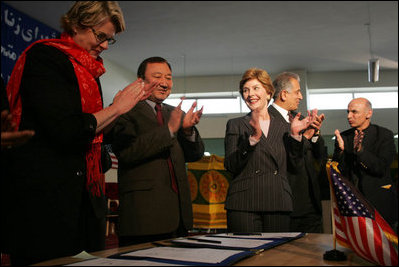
268, 105, 329, 220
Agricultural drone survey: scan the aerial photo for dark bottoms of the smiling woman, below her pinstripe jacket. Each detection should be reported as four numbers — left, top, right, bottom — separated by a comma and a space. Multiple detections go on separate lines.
227, 210, 290, 232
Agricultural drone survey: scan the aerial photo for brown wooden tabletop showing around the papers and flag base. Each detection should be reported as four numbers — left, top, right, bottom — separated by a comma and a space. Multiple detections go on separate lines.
33, 234, 374, 266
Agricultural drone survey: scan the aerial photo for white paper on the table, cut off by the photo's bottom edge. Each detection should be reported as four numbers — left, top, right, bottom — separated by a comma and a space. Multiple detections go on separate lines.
65, 258, 184, 266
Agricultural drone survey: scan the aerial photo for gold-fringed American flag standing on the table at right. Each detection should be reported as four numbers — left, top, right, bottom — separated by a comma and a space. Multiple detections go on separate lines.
327, 162, 398, 266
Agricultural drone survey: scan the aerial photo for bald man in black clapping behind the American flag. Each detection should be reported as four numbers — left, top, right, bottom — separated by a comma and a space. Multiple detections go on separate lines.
333, 98, 398, 232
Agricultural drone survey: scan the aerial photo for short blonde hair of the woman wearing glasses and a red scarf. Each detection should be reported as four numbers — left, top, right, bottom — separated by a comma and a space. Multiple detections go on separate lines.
61, 1, 125, 36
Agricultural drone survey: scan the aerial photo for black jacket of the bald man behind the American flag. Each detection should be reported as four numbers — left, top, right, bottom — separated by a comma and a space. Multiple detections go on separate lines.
333, 124, 398, 228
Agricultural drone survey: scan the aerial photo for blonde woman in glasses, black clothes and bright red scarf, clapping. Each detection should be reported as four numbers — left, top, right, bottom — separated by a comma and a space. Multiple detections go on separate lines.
1, 1, 157, 265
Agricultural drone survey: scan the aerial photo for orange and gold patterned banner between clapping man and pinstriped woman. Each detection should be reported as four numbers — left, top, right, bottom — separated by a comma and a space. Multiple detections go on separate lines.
187, 155, 231, 229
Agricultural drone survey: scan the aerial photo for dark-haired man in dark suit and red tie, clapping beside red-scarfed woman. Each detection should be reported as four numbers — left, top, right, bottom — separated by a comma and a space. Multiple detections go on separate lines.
112, 57, 204, 246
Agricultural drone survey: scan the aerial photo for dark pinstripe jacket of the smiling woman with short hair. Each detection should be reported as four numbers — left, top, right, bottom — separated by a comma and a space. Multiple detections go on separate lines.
224, 113, 300, 211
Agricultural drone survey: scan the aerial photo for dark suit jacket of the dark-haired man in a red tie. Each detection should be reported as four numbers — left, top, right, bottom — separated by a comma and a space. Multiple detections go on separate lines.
112, 101, 204, 236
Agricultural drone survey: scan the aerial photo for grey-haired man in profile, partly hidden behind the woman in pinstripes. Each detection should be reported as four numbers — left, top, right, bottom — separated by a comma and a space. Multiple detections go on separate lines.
269, 72, 329, 233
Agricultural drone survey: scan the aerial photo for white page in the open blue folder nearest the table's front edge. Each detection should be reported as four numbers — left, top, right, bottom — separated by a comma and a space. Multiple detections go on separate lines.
120, 247, 250, 264
